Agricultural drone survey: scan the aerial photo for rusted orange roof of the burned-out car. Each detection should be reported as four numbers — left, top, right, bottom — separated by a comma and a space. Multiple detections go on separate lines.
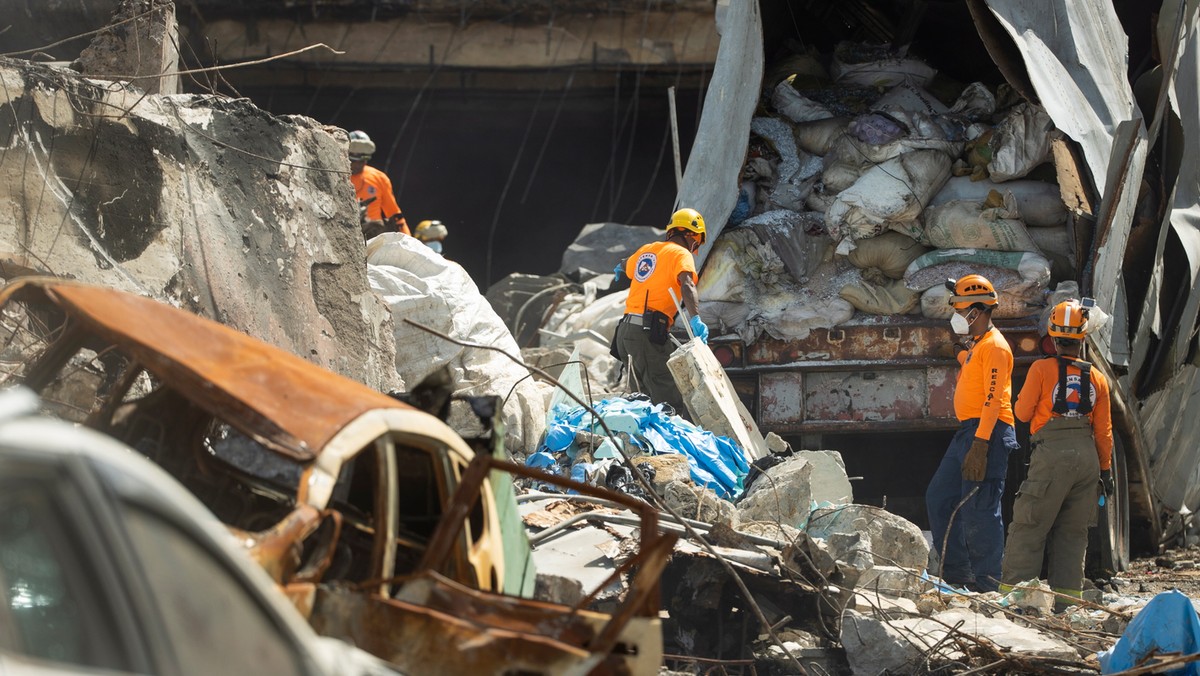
0, 279, 410, 461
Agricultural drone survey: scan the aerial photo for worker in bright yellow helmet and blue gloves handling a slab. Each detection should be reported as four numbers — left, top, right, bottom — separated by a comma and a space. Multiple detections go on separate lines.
613, 209, 708, 418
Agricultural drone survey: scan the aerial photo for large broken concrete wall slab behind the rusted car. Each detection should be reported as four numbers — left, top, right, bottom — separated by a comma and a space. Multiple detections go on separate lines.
0, 59, 400, 389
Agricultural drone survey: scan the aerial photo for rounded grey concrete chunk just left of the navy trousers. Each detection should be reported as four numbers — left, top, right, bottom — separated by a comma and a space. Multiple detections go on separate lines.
806, 504, 929, 570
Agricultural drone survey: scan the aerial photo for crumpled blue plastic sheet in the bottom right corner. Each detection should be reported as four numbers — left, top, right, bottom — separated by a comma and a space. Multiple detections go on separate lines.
1097, 590, 1200, 676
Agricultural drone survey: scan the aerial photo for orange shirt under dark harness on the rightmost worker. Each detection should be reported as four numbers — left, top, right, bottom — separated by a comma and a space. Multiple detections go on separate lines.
1014, 357, 1112, 469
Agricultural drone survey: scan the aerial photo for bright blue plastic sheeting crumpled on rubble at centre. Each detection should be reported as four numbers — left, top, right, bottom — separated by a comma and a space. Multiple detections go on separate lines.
535, 399, 750, 499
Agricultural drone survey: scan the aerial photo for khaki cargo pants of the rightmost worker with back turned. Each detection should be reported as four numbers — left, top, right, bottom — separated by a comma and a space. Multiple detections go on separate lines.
1001, 417, 1100, 598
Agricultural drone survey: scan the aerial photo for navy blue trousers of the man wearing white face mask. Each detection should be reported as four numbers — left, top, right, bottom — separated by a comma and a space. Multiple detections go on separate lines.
925, 418, 1016, 591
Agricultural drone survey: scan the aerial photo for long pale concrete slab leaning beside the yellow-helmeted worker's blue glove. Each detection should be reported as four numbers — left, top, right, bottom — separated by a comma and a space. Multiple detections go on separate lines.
667, 340, 768, 461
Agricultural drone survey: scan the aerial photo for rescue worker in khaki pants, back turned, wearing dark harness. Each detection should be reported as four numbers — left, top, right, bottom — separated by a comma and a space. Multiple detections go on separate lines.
1000, 298, 1114, 610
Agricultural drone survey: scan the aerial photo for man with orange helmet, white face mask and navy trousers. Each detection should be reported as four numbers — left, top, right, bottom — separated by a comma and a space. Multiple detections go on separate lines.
925, 275, 1018, 591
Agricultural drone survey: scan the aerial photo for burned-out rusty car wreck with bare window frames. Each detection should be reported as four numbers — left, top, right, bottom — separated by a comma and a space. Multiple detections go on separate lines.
0, 277, 674, 674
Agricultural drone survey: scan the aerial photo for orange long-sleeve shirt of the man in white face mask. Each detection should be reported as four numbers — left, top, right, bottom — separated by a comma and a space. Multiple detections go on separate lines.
954, 327, 1014, 439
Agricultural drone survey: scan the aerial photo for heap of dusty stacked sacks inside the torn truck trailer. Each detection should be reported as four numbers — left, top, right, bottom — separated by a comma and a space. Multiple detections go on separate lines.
701, 43, 1074, 340
